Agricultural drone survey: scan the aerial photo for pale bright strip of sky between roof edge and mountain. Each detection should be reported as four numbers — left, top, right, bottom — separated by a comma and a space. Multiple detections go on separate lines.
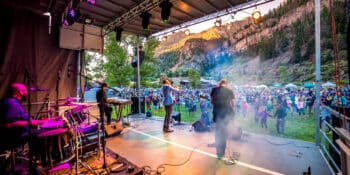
159, 0, 286, 38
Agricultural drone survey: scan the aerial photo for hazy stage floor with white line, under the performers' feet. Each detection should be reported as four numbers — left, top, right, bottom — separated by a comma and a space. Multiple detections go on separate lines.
107, 117, 332, 175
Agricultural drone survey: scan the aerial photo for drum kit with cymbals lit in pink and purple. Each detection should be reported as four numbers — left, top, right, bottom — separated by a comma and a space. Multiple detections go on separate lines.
32, 97, 103, 174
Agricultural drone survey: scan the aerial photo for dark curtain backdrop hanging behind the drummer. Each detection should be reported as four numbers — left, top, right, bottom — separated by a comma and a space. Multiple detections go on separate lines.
0, 1, 78, 106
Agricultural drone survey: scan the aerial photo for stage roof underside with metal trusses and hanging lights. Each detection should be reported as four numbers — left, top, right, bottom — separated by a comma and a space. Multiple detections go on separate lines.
37, 0, 257, 36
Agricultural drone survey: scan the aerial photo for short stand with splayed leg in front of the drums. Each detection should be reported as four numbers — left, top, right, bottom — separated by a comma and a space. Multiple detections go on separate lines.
74, 122, 99, 175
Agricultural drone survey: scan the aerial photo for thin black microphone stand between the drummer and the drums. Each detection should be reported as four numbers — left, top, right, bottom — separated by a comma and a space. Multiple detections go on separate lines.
24, 69, 35, 174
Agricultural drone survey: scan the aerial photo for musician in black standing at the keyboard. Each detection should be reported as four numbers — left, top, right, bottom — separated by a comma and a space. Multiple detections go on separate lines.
96, 83, 113, 124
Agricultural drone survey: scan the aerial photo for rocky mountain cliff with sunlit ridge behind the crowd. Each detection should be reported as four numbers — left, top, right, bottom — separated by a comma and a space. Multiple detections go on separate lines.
156, 0, 348, 84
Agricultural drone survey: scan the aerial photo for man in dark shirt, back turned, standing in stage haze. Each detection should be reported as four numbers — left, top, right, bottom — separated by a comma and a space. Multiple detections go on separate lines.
210, 79, 235, 159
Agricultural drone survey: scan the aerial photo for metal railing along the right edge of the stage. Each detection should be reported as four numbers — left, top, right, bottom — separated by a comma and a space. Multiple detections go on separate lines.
320, 106, 350, 173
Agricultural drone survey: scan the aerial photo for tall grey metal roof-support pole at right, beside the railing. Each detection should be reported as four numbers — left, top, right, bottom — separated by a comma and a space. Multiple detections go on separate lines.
315, 0, 321, 146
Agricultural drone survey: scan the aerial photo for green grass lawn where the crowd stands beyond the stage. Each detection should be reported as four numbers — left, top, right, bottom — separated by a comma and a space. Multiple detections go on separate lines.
113, 105, 315, 142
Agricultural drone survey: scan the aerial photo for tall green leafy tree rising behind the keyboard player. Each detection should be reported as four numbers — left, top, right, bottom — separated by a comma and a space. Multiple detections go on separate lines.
103, 32, 132, 86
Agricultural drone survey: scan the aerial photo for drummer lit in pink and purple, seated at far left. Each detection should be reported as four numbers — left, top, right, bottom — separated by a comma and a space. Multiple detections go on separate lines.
0, 83, 45, 143
